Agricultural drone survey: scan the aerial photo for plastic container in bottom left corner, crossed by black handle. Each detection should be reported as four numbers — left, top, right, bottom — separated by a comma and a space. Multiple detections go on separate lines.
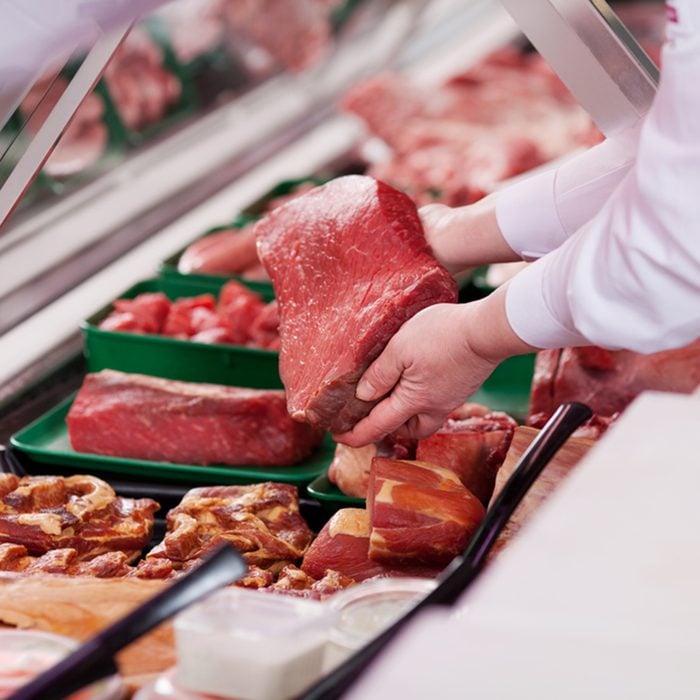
0, 630, 126, 700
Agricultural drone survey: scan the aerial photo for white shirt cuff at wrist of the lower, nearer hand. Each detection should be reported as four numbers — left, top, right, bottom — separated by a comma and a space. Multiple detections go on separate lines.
506, 255, 590, 349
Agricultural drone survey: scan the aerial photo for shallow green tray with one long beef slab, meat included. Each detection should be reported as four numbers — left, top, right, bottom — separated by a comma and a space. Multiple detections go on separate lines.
11, 370, 333, 485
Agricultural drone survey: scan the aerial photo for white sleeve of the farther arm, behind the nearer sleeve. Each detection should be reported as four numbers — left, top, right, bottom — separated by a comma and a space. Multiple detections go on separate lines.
496, 120, 641, 260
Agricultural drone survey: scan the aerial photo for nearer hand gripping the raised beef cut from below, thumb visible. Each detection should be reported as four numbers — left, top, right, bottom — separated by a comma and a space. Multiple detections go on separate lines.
334, 288, 534, 447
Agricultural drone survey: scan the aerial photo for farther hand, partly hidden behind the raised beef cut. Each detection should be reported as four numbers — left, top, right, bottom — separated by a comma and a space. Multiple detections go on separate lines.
418, 195, 520, 275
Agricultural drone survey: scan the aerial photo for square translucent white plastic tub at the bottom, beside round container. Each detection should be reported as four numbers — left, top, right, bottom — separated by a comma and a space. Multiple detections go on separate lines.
175, 588, 335, 700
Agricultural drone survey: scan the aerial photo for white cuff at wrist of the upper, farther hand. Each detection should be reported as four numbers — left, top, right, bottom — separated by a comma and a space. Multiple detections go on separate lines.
496, 168, 565, 260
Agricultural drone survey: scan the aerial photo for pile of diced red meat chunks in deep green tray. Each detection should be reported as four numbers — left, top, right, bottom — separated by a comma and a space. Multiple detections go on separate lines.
99, 281, 279, 350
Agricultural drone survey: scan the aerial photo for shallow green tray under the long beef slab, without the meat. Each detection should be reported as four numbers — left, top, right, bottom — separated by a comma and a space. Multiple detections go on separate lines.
10, 396, 335, 486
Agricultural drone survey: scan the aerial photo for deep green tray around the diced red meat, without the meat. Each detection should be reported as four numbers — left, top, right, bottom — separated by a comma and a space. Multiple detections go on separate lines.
80, 279, 282, 389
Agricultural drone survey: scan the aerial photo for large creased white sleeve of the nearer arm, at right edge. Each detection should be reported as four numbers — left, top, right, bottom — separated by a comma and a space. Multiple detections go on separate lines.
506, 6, 700, 353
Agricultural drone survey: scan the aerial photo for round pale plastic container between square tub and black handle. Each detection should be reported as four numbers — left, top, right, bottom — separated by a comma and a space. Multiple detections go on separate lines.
323, 578, 437, 673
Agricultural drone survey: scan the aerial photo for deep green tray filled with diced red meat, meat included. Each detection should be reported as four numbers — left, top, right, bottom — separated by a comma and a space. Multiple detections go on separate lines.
81, 279, 282, 389
